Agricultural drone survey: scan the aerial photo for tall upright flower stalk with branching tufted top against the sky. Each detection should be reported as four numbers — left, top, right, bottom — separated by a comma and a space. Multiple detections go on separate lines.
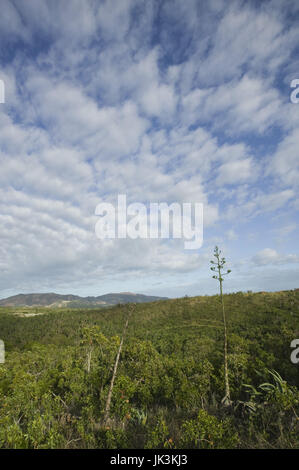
211, 246, 232, 406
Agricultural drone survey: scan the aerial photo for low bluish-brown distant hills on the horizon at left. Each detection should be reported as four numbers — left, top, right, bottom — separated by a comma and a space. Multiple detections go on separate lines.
0, 292, 167, 307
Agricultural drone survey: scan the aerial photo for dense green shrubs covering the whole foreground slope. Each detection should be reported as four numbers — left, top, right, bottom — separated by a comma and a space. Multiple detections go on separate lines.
0, 290, 299, 449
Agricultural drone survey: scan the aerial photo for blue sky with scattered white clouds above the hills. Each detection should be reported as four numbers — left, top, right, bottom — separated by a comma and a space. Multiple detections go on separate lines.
0, 0, 299, 298
